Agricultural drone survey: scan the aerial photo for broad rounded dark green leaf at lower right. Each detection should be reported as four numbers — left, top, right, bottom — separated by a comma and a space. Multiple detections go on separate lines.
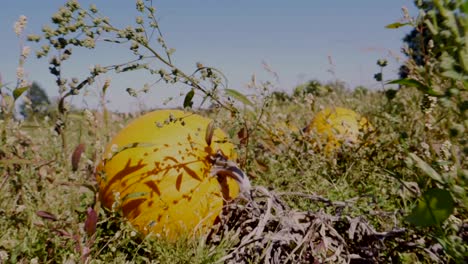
406, 188, 454, 227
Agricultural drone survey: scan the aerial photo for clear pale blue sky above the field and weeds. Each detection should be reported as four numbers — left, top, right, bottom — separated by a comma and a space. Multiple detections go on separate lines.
0, 0, 415, 110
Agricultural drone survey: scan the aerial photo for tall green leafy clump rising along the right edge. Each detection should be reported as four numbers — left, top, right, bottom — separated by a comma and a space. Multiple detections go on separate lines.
388, 0, 468, 262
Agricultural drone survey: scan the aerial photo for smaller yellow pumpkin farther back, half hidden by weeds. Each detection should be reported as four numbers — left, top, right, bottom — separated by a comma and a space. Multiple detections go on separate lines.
304, 107, 372, 153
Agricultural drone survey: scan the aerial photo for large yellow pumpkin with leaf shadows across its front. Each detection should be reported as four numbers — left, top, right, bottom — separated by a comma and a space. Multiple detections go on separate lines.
96, 110, 239, 240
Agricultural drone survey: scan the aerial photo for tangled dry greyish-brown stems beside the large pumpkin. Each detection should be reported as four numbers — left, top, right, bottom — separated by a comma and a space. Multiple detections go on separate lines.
212, 187, 412, 263
